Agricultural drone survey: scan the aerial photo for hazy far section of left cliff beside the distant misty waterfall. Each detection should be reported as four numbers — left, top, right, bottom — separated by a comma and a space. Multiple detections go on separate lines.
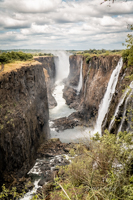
35, 56, 57, 108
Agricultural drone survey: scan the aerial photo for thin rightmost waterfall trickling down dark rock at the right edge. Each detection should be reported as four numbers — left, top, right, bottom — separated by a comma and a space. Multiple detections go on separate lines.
118, 81, 133, 133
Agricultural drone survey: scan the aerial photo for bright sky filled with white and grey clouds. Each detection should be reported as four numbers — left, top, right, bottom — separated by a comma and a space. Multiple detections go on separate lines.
0, 0, 133, 50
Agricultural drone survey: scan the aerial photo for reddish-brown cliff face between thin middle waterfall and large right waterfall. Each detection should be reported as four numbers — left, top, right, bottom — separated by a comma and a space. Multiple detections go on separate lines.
82, 56, 120, 122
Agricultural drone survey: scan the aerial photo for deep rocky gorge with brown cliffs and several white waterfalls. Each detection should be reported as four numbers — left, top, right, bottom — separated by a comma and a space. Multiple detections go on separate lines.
0, 51, 133, 198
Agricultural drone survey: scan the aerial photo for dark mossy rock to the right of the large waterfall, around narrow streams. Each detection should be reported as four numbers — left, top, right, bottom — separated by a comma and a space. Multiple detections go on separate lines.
102, 63, 133, 134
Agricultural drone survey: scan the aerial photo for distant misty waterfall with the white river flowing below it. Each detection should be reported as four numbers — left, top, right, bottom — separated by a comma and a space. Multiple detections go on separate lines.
49, 51, 75, 120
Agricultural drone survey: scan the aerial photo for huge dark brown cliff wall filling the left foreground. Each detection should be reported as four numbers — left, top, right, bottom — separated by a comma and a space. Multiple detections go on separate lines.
0, 64, 49, 185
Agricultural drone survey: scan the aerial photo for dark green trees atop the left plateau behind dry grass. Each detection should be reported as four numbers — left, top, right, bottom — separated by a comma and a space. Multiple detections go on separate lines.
0, 51, 33, 64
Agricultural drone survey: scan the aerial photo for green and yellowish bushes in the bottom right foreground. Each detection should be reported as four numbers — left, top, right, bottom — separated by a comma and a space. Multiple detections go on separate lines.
51, 131, 133, 200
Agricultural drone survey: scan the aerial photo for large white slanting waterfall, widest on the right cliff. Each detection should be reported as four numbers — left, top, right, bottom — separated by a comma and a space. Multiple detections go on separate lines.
94, 58, 123, 135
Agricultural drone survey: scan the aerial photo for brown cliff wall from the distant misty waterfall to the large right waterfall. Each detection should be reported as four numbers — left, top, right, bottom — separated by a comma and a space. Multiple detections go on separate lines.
64, 55, 120, 124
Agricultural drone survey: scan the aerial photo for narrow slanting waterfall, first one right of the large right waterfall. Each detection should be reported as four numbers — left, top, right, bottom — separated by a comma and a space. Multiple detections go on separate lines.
109, 81, 133, 131
